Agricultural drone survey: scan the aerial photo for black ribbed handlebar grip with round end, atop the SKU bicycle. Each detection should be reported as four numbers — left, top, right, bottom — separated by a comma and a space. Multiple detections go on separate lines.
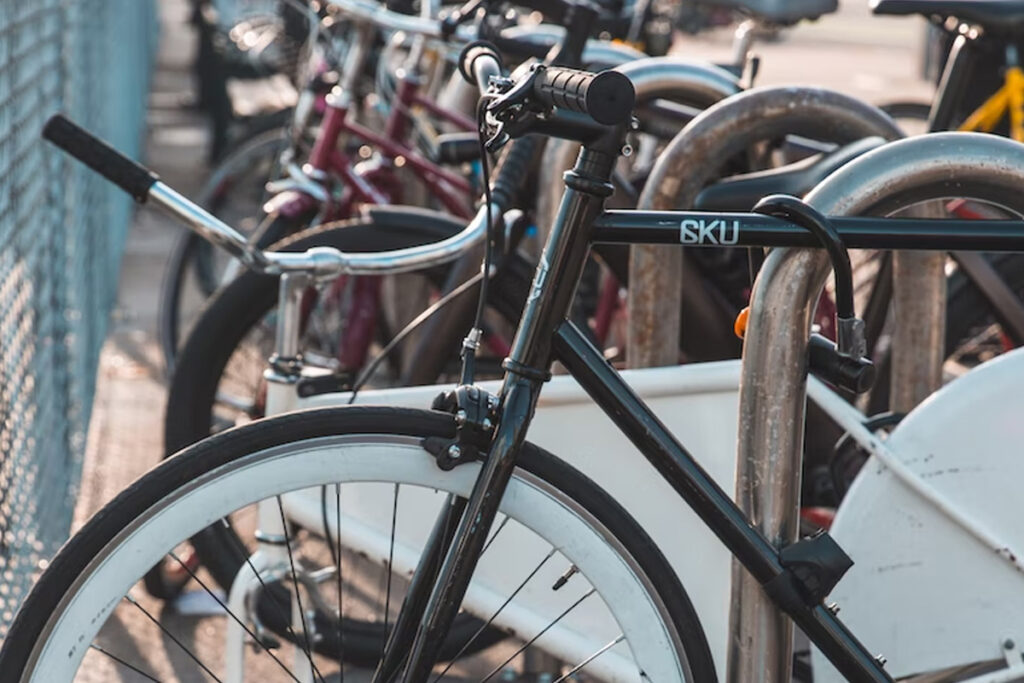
534, 67, 636, 126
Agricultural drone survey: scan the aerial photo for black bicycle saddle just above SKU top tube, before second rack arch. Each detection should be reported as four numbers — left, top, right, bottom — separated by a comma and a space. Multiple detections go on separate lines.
693, 137, 885, 211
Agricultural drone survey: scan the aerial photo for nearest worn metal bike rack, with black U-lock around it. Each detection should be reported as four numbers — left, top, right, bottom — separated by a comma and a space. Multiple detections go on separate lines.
728, 133, 1024, 683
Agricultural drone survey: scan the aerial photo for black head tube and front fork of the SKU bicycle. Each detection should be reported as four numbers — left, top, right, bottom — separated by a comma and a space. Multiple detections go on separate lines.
374, 141, 622, 683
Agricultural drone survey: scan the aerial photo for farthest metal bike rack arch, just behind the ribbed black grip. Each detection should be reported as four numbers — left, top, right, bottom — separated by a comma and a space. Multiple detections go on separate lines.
537, 57, 742, 244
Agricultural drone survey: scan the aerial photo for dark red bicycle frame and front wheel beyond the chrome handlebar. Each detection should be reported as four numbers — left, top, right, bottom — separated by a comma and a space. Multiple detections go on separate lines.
160, 9, 475, 374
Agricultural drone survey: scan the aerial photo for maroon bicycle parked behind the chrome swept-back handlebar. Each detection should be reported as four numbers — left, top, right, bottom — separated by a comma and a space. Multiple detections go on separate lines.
160, 0, 473, 374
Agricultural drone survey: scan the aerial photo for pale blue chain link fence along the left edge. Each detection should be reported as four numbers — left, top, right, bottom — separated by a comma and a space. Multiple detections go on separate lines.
0, 0, 157, 639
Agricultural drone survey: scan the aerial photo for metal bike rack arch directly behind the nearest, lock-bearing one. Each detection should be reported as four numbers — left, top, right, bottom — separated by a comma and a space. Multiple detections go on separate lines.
627, 87, 902, 370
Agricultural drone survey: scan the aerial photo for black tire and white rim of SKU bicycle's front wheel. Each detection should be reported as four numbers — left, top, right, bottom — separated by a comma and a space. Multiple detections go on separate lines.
0, 407, 716, 683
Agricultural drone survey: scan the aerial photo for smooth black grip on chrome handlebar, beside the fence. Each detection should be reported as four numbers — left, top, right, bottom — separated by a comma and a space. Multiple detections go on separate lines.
43, 114, 160, 204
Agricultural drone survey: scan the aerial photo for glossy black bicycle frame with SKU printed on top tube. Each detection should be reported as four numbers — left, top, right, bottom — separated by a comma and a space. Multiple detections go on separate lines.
378, 120, 1024, 683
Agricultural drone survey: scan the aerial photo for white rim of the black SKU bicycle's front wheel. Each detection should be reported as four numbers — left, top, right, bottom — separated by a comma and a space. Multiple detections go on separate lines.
23, 435, 689, 683
